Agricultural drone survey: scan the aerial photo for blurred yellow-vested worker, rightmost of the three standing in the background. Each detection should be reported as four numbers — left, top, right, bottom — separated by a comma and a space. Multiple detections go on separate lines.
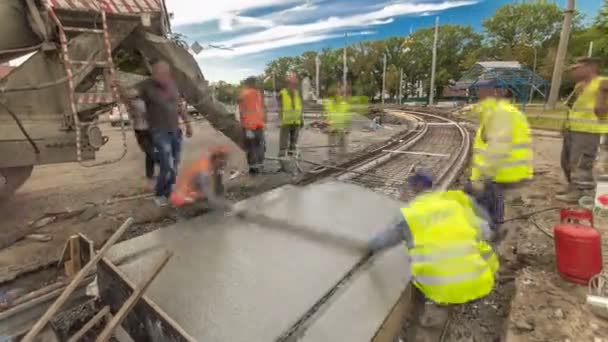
324, 83, 352, 156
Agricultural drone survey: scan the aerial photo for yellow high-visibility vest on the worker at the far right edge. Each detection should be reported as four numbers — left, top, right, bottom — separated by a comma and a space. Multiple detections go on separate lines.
566, 76, 608, 134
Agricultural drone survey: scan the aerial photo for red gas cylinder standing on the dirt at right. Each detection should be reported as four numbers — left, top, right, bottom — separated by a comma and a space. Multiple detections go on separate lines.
553, 209, 603, 285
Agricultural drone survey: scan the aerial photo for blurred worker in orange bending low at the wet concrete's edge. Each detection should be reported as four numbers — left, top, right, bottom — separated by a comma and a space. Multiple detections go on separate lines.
169, 146, 233, 211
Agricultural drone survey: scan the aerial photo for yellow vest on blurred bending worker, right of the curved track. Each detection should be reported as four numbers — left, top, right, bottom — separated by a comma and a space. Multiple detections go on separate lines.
470, 98, 534, 183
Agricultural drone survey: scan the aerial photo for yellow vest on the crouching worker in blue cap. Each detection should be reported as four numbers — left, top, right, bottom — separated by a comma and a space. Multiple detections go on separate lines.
401, 191, 499, 304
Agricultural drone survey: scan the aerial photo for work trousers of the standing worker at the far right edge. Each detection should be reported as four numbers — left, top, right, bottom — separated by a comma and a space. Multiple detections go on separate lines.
561, 131, 600, 190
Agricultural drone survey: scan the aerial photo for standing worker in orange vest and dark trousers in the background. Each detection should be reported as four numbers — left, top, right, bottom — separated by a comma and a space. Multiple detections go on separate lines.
239, 77, 266, 174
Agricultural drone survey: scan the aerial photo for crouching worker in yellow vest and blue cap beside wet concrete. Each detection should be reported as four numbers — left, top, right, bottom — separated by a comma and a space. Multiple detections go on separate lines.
369, 169, 499, 334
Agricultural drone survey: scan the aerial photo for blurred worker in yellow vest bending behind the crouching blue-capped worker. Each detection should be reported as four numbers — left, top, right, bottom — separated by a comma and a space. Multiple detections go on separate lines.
465, 95, 533, 225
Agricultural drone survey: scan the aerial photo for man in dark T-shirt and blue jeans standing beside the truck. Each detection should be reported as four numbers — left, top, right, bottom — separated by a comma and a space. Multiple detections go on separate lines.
116, 61, 192, 206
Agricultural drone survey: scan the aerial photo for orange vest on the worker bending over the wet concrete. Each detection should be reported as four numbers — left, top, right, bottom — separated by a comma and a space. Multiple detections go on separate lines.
169, 154, 210, 207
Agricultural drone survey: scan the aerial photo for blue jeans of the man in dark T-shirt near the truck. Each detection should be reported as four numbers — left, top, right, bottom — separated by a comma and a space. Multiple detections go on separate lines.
152, 130, 182, 198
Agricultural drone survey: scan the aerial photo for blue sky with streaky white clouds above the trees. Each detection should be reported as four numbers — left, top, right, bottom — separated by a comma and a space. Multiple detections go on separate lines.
166, 0, 601, 83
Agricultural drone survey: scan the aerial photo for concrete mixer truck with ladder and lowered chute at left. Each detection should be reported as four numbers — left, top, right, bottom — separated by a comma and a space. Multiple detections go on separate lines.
0, 0, 242, 200
